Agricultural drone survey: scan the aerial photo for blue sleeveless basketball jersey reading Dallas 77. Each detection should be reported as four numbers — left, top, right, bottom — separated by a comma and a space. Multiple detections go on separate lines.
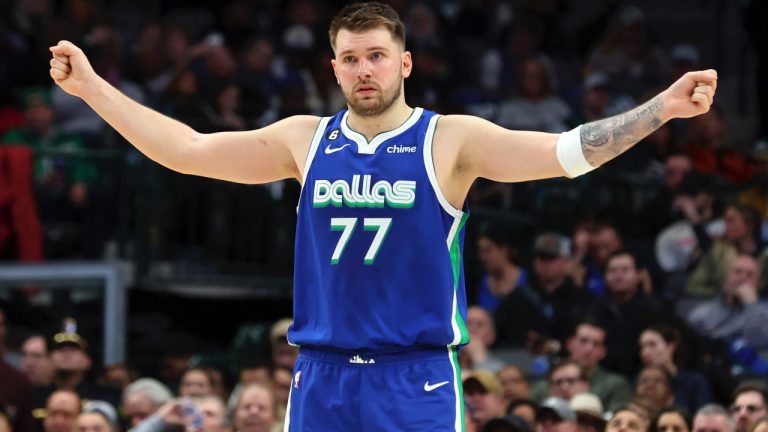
288, 108, 469, 351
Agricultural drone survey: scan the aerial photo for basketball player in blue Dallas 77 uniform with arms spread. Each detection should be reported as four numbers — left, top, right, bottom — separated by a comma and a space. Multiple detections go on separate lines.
50, 3, 717, 431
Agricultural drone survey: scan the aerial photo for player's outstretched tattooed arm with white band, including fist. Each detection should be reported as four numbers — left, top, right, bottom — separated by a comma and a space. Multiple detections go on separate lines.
444, 70, 717, 189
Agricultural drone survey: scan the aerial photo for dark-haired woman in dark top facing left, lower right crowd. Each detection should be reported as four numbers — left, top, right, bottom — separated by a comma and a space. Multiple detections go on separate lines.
639, 325, 712, 412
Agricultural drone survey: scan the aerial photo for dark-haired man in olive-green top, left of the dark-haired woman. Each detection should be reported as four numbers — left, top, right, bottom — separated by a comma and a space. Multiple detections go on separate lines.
566, 320, 632, 411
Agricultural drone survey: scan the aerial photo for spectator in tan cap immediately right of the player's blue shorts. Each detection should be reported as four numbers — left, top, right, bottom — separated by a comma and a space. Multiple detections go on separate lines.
463, 370, 504, 430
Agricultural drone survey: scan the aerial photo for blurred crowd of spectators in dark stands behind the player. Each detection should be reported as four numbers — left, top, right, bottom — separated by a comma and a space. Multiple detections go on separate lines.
0, 0, 768, 432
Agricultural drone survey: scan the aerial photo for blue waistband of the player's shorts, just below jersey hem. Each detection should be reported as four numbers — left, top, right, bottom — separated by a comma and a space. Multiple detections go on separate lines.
299, 346, 455, 365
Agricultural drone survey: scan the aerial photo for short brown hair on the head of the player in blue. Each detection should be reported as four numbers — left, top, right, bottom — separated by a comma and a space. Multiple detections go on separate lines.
328, 2, 405, 51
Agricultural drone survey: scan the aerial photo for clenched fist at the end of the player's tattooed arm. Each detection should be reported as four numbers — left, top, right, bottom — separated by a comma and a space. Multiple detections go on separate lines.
662, 69, 717, 119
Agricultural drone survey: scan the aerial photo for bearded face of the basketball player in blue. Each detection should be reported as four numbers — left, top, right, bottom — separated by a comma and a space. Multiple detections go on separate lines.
331, 27, 411, 117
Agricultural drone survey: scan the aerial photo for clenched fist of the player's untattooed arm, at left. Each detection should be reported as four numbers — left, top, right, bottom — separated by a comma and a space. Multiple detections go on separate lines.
49, 41, 97, 97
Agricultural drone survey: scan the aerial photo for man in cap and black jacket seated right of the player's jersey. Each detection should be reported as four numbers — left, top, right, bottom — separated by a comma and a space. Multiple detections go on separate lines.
496, 233, 593, 351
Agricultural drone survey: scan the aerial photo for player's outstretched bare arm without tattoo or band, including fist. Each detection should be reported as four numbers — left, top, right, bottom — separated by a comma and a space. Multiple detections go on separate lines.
50, 41, 319, 183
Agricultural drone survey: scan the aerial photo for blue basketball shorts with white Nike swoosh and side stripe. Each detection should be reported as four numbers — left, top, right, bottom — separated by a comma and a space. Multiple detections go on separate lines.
284, 347, 464, 432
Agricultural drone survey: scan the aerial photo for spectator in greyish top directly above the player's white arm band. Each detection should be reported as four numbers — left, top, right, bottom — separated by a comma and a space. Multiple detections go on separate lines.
496, 57, 571, 133
